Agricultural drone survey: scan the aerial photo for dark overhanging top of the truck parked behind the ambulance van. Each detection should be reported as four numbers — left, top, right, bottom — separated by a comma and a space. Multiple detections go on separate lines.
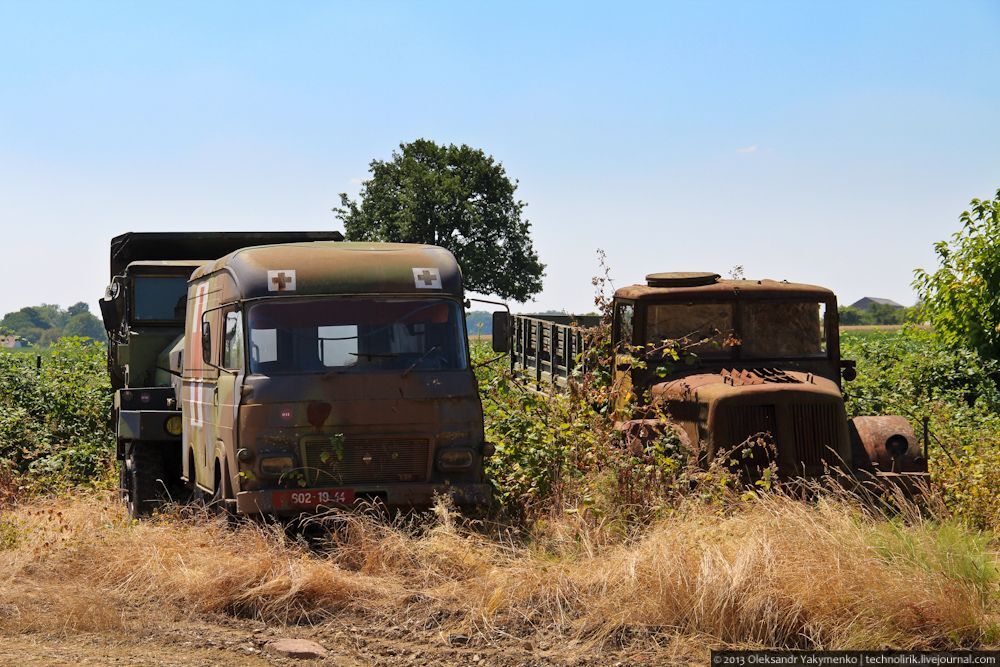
111, 231, 344, 278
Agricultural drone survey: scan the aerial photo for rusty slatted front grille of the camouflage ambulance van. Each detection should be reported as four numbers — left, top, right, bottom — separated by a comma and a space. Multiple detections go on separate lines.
301, 436, 430, 485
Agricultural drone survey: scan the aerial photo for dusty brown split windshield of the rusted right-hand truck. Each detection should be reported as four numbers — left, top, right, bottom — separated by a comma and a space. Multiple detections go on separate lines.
646, 301, 826, 359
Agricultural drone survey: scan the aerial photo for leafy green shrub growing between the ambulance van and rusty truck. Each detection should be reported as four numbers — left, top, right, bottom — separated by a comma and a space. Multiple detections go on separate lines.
473, 329, 739, 526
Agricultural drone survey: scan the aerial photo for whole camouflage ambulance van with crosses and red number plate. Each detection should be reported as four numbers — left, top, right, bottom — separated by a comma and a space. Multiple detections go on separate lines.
182, 243, 490, 515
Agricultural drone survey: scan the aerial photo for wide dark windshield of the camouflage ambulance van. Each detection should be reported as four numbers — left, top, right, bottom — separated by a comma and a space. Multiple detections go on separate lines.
248, 298, 467, 375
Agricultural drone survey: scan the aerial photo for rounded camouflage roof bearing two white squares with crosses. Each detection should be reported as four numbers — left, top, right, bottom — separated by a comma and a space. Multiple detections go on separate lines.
191, 242, 462, 299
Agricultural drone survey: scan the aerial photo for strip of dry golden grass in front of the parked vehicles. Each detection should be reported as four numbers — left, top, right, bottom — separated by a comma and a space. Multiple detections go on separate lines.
0, 495, 998, 649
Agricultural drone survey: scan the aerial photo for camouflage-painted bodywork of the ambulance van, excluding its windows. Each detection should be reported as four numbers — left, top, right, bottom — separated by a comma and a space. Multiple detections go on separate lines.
181, 242, 491, 514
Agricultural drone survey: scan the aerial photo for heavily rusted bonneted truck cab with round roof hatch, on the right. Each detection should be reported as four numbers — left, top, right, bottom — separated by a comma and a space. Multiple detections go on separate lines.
613, 273, 927, 486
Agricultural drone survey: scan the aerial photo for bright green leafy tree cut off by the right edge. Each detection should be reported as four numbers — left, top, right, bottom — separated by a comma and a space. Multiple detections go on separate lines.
913, 189, 1000, 359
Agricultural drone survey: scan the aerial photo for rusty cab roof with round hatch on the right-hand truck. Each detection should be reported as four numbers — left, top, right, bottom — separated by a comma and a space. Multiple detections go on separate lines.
615, 274, 836, 301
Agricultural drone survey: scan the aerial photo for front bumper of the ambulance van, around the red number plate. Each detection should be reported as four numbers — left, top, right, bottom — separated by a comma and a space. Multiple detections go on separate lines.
236, 484, 493, 516
